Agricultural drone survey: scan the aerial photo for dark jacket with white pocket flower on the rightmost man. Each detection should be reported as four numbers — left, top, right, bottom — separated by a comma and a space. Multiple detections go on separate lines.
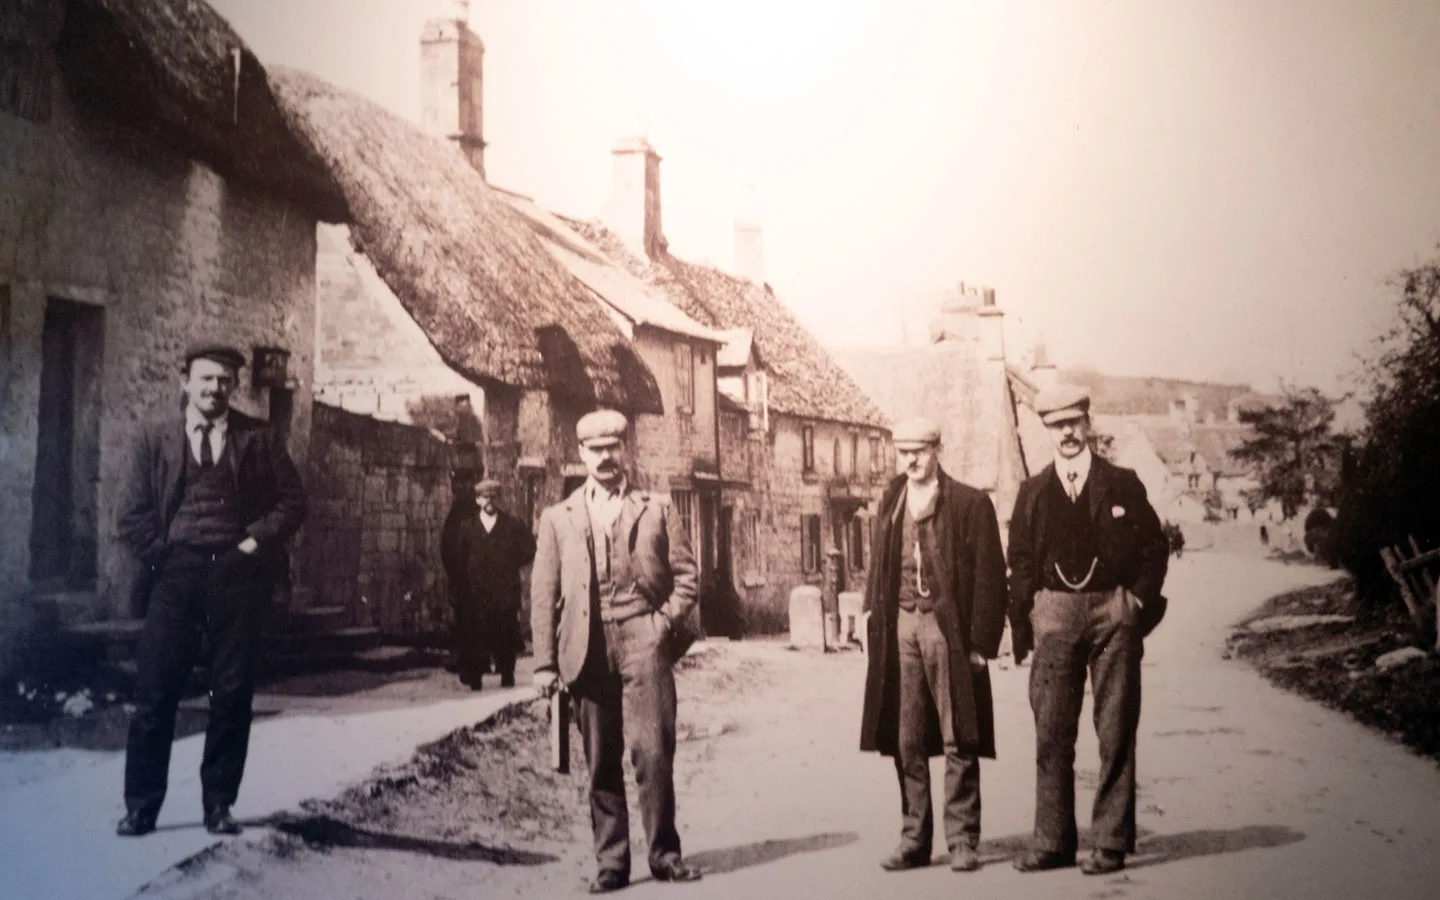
1009, 456, 1169, 661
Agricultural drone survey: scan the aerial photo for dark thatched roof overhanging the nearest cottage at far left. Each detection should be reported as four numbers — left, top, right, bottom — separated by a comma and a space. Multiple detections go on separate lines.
55, 0, 344, 220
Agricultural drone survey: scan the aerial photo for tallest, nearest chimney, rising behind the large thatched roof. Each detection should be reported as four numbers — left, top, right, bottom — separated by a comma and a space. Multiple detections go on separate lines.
420, 0, 485, 177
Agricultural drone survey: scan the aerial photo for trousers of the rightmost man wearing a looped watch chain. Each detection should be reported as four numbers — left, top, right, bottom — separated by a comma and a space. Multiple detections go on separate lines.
1030, 589, 1142, 854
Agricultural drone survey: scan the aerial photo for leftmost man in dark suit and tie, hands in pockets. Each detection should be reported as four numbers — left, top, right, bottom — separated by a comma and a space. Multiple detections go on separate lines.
115, 346, 305, 837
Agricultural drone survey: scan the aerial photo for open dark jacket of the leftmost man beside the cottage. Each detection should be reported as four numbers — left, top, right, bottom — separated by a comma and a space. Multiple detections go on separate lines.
120, 409, 305, 609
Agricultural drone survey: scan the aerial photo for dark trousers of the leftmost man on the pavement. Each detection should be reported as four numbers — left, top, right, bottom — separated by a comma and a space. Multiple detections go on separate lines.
125, 547, 271, 815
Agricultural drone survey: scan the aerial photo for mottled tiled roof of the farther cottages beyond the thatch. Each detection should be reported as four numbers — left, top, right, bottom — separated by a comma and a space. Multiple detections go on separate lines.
572, 222, 890, 428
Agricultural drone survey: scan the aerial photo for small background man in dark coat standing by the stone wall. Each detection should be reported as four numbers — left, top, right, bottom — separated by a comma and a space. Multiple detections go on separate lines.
449, 478, 536, 691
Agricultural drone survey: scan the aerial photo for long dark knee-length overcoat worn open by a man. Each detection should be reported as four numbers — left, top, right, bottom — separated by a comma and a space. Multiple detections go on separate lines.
860, 471, 1007, 757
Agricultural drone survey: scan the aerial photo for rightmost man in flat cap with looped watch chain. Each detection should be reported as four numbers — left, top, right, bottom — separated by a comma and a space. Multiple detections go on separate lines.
1009, 386, 1169, 876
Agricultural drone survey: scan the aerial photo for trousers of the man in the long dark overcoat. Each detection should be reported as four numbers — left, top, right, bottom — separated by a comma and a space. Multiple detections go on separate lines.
896, 608, 981, 854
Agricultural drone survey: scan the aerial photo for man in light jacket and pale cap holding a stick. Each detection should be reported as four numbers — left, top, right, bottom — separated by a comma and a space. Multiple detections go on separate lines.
530, 410, 700, 894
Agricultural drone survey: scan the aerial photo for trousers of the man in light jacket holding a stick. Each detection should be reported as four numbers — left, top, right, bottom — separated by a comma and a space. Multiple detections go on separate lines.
570, 613, 680, 876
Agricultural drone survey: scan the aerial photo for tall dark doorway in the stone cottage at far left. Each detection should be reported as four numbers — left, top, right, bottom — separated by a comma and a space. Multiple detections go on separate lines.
30, 297, 105, 590
